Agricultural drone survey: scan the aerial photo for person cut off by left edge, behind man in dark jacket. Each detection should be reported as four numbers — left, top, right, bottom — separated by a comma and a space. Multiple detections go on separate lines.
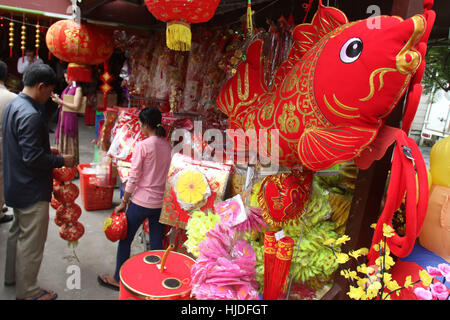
0, 61, 17, 223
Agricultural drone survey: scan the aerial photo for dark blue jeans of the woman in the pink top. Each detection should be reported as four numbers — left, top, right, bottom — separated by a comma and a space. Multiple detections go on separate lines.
114, 201, 164, 281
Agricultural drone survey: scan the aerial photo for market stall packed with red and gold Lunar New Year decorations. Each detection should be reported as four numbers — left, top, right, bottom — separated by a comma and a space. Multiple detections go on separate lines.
4, 0, 446, 300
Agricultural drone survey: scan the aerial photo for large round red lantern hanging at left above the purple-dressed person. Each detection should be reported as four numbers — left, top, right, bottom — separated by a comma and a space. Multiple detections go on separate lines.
45, 20, 114, 82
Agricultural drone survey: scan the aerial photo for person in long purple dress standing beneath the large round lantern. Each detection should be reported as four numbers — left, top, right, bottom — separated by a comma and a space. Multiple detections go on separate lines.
52, 70, 83, 165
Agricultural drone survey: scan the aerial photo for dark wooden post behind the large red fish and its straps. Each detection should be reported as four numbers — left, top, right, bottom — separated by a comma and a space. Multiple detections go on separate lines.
322, 0, 423, 300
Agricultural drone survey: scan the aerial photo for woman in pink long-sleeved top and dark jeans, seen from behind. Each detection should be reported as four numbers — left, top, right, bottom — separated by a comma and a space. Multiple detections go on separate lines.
98, 108, 171, 290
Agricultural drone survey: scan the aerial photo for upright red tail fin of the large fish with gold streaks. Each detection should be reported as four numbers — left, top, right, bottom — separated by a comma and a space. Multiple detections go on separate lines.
216, 39, 267, 119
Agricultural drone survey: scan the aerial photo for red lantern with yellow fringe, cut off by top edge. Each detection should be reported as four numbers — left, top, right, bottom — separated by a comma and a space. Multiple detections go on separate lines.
145, 0, 220, 51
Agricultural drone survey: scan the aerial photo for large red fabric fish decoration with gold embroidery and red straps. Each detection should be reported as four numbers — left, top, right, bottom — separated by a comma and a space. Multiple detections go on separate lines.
216, 0, 435, 256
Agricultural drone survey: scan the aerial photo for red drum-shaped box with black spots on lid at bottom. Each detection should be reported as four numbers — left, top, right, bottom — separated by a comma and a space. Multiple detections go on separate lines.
119, 245, 195, 300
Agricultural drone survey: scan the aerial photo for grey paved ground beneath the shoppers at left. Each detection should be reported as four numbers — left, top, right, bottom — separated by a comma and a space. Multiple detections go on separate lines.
0, 118, 144, 300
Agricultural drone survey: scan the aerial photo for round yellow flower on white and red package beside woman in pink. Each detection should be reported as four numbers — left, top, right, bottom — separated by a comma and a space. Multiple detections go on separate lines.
175, 170, 207, 204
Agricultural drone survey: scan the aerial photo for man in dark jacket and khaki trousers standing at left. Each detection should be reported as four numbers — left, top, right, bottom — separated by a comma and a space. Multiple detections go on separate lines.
2, 64, 74, 300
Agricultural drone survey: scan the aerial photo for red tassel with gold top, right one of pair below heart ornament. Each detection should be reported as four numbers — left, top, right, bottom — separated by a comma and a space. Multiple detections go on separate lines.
264, 237, 294, 300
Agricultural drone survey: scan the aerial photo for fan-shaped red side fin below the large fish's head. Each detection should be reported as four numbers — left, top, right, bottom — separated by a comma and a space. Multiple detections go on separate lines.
297, 126, 377, 171
